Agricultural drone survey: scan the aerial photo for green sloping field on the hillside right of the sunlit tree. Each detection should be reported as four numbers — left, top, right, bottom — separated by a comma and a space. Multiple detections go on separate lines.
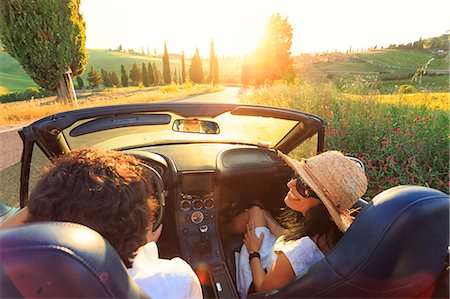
297, 49, 449, 93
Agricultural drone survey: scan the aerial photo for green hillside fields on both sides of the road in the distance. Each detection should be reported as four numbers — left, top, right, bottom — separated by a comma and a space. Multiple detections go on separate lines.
0, 49, 449, 94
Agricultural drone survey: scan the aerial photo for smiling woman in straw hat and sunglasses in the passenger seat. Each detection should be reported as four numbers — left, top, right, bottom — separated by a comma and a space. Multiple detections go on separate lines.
234, 151, 367, 298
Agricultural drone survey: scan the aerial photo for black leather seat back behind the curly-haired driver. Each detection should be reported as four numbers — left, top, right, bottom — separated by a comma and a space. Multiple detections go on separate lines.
0, 222, 148, 298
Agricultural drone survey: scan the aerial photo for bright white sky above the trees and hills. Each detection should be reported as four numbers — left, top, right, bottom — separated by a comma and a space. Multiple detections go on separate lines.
81, 0, 450, 56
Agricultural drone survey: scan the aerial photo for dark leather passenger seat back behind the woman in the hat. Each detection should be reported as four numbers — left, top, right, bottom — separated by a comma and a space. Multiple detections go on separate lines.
250, 186, 449, 298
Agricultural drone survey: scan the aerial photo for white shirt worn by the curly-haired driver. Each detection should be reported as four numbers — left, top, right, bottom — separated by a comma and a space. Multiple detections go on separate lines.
128, 242, 203, 299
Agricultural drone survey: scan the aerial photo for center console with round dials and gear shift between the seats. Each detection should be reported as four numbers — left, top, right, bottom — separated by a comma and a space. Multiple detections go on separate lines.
176, 171, 238, 298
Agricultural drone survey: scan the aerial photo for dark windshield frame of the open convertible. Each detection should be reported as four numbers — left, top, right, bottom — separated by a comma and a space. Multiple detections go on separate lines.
19, 102, 327, 207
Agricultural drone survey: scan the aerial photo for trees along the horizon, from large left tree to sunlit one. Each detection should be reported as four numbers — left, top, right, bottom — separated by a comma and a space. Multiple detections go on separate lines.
0, 0, 295, 105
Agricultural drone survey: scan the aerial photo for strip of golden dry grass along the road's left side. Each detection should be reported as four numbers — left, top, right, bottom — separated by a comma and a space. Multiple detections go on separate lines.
0, 83, 222, 125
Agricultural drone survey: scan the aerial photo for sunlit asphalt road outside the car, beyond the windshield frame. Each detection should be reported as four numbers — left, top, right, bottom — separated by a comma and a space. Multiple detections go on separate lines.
0, 87, 243, 171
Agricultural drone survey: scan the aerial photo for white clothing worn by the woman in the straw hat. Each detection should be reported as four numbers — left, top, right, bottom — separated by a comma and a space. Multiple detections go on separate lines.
235, 227, 325, 298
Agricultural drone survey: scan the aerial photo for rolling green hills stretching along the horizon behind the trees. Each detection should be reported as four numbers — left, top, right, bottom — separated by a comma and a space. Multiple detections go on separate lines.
0, 49, 449, 94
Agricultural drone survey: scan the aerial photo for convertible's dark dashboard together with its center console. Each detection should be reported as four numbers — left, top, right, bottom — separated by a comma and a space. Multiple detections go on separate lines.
127, 143, 292, 298
